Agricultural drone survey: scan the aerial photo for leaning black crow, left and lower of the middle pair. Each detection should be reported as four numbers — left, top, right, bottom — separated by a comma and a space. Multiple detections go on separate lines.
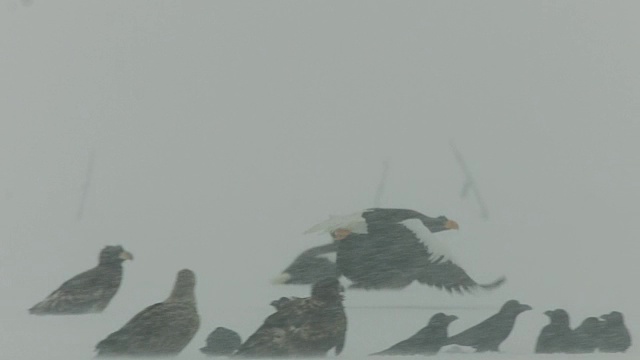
371, 313, 458, 355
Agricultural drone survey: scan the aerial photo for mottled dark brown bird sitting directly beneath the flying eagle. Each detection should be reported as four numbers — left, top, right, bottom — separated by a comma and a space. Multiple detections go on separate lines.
235, 278, 347, 357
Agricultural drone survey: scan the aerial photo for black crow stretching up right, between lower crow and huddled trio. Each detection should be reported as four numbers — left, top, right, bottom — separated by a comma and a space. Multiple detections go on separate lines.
445, 300, 531, 352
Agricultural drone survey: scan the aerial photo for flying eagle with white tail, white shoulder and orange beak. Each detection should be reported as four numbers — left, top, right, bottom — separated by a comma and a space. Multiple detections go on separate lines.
305, 208, 505, 293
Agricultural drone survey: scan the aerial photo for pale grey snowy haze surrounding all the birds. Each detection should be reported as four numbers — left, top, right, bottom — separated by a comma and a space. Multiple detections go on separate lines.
0, 0, 640, 360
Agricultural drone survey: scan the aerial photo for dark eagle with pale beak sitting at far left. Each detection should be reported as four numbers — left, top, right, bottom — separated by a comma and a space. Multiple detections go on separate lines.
29, 246, 133, 315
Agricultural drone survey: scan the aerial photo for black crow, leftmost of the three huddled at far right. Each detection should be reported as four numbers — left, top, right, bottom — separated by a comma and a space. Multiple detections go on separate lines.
535, 309, 573, 354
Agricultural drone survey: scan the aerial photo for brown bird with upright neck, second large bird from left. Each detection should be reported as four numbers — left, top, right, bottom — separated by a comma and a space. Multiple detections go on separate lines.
96, 269, 200, 356
